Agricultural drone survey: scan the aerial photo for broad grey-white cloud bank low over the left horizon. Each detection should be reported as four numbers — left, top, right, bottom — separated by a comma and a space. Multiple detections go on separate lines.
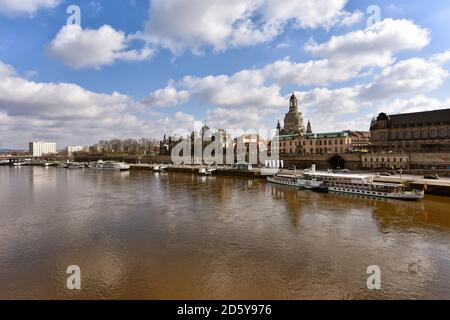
0, 62, 199, 147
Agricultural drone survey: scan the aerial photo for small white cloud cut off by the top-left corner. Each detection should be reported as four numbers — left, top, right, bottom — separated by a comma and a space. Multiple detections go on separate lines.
0, 0, 61, 16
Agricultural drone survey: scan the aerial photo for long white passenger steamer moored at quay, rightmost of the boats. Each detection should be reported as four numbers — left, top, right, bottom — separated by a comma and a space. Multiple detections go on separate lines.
303, 171, 425, 200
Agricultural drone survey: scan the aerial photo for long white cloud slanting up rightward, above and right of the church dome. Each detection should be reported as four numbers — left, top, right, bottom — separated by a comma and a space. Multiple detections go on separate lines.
263, 19, 430, 85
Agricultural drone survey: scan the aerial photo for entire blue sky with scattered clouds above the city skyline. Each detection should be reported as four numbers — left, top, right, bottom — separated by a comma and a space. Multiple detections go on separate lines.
0, 0, 450, 149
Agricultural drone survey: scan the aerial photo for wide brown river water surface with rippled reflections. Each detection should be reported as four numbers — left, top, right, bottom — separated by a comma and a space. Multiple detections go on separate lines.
0, 168, 450, 299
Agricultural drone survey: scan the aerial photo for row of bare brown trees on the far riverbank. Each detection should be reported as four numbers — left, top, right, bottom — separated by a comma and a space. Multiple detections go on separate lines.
91, 138, 159, 155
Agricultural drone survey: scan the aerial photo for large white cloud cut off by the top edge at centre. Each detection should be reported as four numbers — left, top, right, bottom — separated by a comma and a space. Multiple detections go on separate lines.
140, 0, 354, 53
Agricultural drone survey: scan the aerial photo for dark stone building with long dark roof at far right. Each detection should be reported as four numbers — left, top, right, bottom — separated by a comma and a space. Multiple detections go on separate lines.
370, 109, 450, 152
